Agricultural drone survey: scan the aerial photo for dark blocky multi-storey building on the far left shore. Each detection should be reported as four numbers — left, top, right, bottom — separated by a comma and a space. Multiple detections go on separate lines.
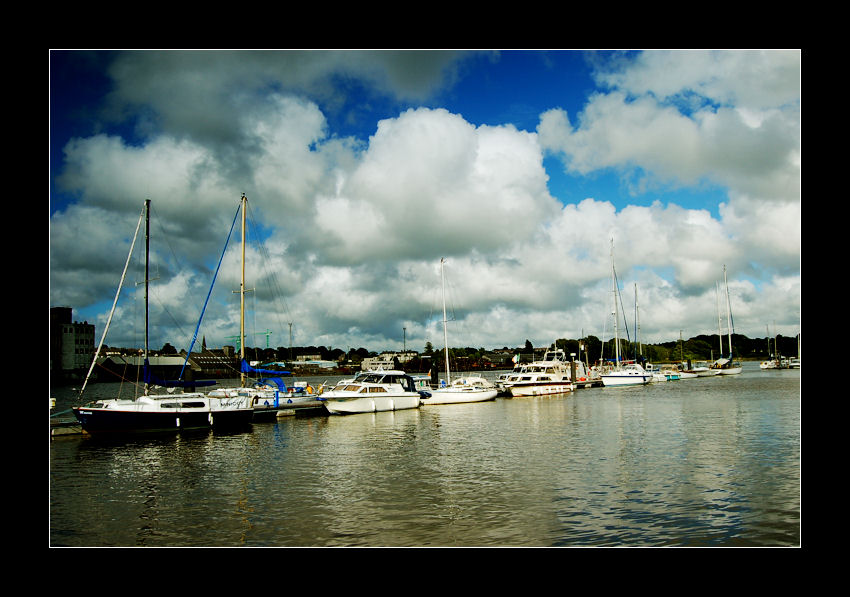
50, 307, 94, 379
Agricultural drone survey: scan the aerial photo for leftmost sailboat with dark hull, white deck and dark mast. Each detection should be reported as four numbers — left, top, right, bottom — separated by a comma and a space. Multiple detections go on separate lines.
72, 200, 254, 434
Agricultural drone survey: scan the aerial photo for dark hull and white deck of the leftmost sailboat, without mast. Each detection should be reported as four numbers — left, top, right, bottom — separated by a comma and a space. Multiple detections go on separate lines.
72, 401, 254, 434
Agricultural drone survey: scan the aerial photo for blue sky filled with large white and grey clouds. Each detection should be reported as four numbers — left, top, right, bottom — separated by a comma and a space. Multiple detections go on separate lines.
48, 50, 801, 352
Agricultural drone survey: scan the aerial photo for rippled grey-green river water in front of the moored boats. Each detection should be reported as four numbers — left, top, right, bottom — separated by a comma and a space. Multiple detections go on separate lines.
49, 363, 801, 547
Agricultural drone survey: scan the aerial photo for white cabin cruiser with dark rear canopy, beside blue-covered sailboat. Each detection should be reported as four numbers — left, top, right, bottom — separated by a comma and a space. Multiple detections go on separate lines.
317, 370, 427, 415
